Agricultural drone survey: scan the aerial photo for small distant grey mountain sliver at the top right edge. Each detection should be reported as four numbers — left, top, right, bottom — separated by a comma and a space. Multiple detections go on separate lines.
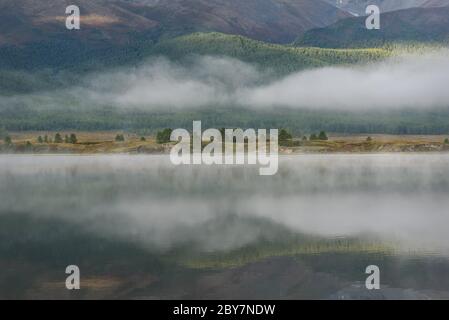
326, 0, 449, 16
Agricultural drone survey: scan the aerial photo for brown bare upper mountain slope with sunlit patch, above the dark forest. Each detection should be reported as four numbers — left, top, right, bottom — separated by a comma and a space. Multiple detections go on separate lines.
0, 0, 347, 46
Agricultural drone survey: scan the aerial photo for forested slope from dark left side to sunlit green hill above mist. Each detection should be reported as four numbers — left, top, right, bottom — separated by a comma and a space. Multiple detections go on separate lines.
0, 33, 392, 94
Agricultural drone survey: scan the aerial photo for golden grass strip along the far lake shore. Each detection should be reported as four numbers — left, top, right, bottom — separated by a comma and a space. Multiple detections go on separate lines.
0, 131, 449, 154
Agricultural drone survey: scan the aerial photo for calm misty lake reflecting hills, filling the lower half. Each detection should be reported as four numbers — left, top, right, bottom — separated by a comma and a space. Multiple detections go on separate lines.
0, 154, 449, 299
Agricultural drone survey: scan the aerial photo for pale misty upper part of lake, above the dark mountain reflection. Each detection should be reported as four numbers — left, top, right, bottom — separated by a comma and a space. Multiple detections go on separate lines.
0, 154, 449, 256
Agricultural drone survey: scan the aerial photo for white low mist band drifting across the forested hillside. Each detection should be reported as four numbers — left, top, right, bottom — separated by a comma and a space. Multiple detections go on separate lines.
0, 49, 449, 111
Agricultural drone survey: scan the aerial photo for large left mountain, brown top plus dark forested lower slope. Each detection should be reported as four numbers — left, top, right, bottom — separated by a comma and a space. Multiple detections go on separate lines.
0, 0, 349, 70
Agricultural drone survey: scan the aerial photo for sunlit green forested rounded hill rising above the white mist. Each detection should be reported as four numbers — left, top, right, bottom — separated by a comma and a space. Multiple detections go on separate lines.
151, 33, 391, 73
